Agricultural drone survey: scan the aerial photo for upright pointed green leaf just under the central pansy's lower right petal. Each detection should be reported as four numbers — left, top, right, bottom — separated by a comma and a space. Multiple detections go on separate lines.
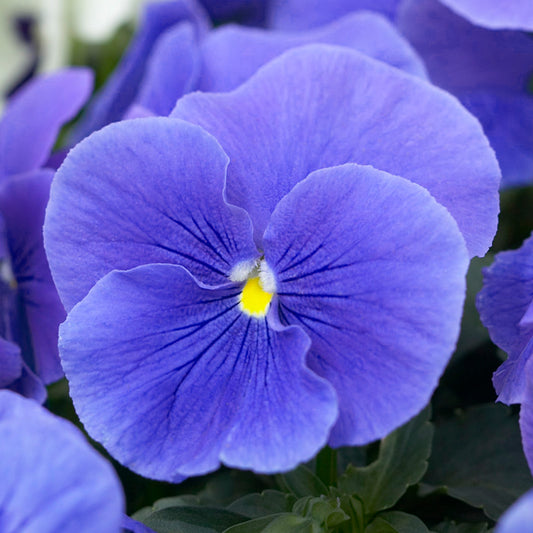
338, 407, 433, 514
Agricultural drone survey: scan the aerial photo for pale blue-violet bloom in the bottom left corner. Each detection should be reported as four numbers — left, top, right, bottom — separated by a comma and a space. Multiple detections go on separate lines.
0, 391, 124, 533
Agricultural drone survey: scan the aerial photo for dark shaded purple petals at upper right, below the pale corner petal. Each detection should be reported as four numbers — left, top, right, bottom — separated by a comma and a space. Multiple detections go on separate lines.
397, 0, 533, 187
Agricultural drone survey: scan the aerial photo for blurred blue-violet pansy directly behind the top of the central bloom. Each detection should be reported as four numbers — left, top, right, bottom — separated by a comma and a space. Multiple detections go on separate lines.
75, 2, 426, 134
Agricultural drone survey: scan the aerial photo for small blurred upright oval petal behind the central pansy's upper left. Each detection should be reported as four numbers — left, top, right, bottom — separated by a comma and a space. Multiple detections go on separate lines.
136, 22, 201, 116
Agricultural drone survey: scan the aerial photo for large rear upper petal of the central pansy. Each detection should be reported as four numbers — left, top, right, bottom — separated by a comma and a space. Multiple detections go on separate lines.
171, 45, 500, 255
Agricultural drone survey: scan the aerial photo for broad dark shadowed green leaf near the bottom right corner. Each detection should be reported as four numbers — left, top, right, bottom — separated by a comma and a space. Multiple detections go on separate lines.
422, 404, 532, 520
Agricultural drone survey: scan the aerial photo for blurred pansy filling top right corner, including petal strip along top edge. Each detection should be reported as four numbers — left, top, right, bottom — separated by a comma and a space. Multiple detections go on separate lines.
270, 0, 533, 187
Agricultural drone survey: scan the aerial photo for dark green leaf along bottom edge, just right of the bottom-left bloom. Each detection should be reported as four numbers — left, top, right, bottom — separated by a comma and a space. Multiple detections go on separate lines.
138, 506, 247, 533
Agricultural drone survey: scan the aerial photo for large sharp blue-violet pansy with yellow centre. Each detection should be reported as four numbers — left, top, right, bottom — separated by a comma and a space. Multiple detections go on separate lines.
45, 46, 499, 481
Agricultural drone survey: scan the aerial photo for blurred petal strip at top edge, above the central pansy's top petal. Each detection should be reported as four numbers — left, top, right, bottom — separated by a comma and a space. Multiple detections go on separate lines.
269, 0, 400, 30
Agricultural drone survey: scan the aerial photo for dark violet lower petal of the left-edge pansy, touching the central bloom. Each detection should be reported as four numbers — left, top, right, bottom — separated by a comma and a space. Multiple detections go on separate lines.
0, 170, 66, 383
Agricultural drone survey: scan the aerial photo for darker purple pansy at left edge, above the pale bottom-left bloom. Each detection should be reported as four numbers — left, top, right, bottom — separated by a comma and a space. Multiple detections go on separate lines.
0, 69, 92, 401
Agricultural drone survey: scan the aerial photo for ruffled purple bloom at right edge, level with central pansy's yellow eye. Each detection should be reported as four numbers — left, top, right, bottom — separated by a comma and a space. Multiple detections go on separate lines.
477, 233, 533, 404
